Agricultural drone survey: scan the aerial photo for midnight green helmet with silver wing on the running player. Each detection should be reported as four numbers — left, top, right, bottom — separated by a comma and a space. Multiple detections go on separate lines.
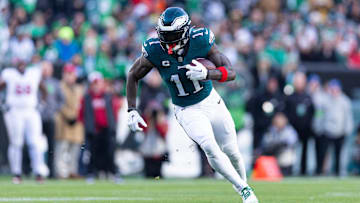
156, 7, 191, 54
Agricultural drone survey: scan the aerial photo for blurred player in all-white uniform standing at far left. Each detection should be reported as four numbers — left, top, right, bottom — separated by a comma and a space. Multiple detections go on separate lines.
0, 62, 47, 183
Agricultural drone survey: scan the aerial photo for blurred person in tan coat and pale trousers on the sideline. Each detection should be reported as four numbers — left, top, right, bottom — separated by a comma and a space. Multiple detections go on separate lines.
55, 64, 84, 178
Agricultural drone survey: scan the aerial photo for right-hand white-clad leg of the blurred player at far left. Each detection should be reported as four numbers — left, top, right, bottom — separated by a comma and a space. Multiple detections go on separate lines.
25, 110, 47, 176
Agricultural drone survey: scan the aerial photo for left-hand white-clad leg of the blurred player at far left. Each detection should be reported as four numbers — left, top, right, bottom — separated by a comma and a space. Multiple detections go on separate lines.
5, 110, 24, 175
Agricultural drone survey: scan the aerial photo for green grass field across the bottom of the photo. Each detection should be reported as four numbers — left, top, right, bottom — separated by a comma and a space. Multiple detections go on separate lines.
0, 177, 360, 203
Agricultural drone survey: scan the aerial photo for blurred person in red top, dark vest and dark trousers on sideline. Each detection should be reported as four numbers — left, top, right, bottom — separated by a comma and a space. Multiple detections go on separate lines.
79, 72, 121, 183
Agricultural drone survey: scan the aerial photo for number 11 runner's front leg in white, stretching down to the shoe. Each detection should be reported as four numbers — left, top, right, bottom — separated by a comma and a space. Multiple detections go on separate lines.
175, 109, 247, 188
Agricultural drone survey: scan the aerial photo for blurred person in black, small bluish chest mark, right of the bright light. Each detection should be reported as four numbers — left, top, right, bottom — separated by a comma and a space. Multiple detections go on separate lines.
285, 72, 315, 175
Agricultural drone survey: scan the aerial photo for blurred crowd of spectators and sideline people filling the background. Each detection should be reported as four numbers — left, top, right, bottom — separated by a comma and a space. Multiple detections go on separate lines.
0, 0, 360, 180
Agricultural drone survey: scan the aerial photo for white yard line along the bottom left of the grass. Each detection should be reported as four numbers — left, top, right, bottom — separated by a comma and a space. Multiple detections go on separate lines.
0, 197, 153, 202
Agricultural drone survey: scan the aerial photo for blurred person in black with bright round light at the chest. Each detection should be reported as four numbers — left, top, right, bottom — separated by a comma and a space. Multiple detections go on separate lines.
247, 75, 284, 158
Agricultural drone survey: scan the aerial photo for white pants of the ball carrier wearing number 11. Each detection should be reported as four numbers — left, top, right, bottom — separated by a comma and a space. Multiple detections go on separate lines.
174, 89, 248, 188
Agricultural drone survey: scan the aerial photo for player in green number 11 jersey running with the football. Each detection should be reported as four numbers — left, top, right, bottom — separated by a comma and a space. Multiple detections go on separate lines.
127, 7, 258, 203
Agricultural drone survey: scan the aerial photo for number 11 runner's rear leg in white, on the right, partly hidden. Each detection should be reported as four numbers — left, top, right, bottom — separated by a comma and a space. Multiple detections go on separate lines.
211, 101, 247, 181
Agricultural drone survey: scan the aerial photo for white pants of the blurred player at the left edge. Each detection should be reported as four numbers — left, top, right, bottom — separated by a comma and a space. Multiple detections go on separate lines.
5, 108, 46, 176
